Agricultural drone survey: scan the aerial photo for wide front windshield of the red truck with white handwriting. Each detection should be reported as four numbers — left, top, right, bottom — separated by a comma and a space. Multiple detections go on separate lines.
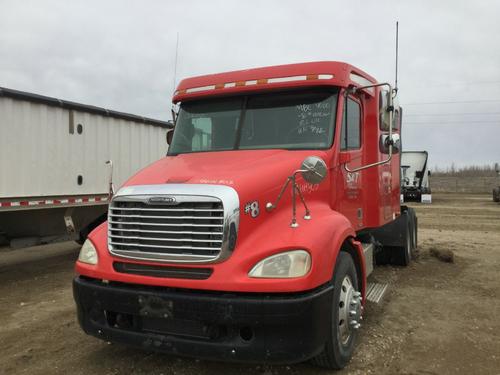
168, 90, 337, 155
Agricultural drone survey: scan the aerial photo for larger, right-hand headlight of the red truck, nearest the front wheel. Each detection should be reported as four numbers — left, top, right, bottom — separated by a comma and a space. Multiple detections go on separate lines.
248, 250, 311, 278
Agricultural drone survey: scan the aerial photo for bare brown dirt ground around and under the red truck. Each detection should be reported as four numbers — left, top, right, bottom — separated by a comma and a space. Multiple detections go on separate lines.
0, 194, 500, 375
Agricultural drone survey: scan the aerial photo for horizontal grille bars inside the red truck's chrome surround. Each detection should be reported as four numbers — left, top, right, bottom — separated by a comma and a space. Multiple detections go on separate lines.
108, 196, 225, 262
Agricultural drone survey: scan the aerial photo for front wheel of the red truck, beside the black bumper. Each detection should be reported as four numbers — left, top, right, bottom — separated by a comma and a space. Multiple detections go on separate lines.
312, 251, 361, 369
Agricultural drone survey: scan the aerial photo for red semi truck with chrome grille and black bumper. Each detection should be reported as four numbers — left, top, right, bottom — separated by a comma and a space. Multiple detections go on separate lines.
73, 62, 417, 368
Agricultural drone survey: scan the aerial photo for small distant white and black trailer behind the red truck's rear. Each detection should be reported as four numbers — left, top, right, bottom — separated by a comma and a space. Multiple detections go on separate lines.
401, 151, 432, 203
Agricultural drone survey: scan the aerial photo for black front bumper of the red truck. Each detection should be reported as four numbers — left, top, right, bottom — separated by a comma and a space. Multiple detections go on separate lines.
73, 277, 333, 363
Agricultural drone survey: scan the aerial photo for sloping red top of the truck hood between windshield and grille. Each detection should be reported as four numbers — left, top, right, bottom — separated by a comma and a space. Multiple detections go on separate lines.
124, 150, 327, 203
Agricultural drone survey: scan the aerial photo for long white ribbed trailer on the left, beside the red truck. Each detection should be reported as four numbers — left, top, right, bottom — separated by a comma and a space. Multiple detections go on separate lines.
0, 88, 171, 247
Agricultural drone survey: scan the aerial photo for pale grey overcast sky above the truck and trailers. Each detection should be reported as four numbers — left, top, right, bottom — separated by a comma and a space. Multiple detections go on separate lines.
0, 0, 500, 167
